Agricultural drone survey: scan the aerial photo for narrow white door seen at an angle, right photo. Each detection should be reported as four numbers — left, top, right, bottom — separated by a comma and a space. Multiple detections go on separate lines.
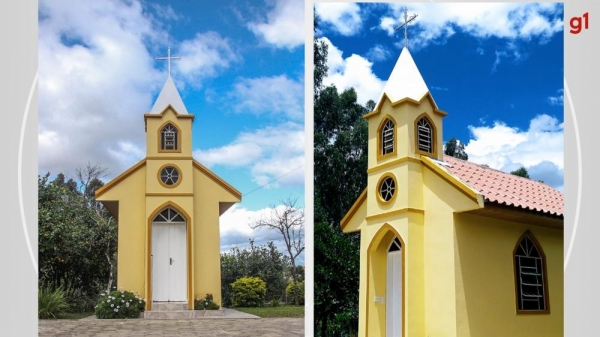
385, 250, 403, 337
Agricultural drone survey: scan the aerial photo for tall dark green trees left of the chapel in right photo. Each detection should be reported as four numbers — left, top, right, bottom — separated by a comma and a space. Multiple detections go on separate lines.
314, 17, 366, 337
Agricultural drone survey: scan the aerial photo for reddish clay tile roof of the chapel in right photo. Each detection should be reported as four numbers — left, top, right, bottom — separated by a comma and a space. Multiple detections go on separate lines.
442, 156, 564, 216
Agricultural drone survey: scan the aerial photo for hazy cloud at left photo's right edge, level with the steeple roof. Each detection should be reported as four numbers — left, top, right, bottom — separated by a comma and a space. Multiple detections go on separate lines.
229, 75, 304, 120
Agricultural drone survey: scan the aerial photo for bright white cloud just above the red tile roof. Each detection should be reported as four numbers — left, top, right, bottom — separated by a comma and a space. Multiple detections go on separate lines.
465, 114, 564, 189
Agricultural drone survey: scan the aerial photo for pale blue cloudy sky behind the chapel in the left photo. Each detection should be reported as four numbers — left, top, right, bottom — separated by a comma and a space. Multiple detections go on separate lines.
38, 0, 305, 260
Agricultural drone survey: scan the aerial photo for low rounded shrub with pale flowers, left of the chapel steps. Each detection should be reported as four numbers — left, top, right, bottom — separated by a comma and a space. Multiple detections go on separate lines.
96, 290, 146, 318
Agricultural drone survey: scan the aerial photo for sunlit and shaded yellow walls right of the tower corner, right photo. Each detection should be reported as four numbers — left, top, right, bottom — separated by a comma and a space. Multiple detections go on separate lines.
423, 164, 563, 337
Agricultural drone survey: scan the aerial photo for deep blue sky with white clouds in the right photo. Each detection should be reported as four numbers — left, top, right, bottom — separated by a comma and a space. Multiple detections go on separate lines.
315, 3, 564, 190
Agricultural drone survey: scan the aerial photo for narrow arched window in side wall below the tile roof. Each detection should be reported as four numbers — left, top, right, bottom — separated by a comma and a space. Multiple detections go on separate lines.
514, 232, 548, 312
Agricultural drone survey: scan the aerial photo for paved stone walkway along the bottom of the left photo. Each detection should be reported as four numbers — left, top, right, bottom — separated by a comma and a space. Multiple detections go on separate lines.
38, 318, 304, 337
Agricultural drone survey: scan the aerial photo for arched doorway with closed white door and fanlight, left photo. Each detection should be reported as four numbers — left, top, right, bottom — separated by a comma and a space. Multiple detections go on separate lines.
152, 207, 187, 302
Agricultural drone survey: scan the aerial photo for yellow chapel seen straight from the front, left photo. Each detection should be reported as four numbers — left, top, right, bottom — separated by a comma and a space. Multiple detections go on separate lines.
96, 74, 242, 310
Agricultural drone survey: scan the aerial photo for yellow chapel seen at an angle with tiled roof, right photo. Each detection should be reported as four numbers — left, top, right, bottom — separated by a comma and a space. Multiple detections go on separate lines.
341, 47, 564, 337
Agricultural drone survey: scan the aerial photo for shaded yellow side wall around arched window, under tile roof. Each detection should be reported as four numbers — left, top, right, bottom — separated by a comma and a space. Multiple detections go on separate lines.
454, 214, 564, 337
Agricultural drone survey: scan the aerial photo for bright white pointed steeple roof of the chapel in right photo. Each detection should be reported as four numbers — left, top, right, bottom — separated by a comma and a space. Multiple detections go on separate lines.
383, 47, 429, 102
